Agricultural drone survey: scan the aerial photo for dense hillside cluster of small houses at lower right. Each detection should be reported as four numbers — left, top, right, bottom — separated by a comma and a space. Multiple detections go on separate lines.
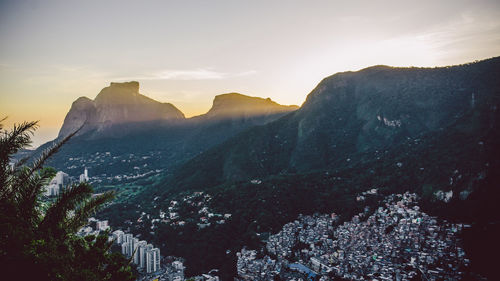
237, 193, 469, 280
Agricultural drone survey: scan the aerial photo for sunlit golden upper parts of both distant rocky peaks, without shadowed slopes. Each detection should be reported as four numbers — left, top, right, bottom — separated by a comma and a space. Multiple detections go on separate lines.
58, 81, 298, 138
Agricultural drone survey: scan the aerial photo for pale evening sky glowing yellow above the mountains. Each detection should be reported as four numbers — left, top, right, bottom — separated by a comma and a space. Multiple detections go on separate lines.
0, 0, 500, 146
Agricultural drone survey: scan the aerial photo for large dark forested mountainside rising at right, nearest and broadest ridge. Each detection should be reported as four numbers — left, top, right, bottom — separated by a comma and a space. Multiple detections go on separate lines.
165, 57, 500, 190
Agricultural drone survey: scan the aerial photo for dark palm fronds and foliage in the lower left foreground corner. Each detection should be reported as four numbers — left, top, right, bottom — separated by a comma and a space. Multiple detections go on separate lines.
0, 122, 135, 280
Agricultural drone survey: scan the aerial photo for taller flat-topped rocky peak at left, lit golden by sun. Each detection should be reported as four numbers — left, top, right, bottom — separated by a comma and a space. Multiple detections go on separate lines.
59, 82, 184, 137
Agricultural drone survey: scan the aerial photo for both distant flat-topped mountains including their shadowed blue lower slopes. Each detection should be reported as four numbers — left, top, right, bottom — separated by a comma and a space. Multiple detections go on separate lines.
38, 81, 298, 179
